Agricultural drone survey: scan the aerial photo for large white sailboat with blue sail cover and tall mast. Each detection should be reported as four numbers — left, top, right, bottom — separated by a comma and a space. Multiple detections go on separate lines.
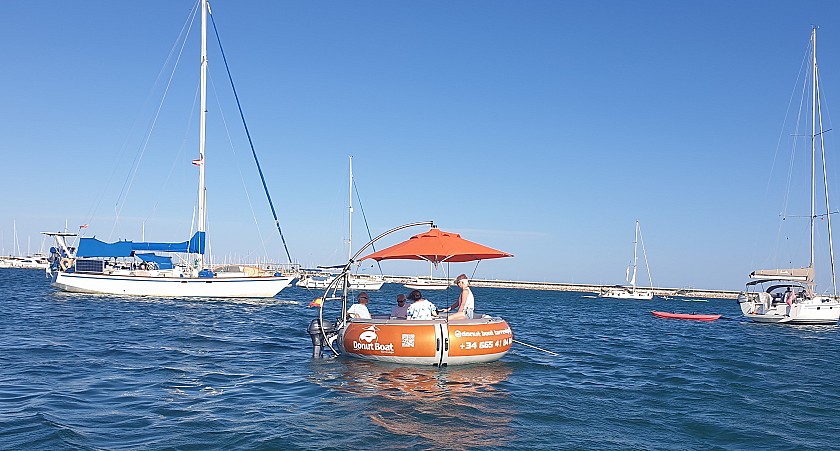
43, 0, 295, 298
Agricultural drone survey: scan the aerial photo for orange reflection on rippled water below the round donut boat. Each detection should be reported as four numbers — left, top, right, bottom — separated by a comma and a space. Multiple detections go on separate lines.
313, 359, 515, 449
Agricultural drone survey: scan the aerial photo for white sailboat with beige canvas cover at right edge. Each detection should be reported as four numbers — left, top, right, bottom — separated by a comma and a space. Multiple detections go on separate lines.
738, 27, 840, 324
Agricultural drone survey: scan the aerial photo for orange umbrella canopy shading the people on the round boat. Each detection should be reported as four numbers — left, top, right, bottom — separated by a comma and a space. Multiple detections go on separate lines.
359, 227, 513, 265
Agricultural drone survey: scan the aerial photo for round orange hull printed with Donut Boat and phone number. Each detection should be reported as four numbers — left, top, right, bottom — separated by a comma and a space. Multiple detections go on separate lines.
340, 317, 513, 366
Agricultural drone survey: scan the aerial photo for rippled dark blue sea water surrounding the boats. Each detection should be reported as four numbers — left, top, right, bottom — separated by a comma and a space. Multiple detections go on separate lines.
0, 269, 840, 450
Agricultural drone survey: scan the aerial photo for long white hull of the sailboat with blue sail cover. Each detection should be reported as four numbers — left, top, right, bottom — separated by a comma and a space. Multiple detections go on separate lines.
52, 272, 294, 298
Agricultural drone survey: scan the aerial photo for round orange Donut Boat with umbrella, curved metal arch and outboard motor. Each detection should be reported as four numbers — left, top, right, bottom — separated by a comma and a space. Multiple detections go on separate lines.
307, 222, 513, 366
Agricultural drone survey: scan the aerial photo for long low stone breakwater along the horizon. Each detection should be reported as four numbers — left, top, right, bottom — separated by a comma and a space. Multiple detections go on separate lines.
384, 276, 738, 299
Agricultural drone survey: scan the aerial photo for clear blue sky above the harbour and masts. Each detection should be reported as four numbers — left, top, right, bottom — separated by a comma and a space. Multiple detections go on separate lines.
0, 0, 840, 289
